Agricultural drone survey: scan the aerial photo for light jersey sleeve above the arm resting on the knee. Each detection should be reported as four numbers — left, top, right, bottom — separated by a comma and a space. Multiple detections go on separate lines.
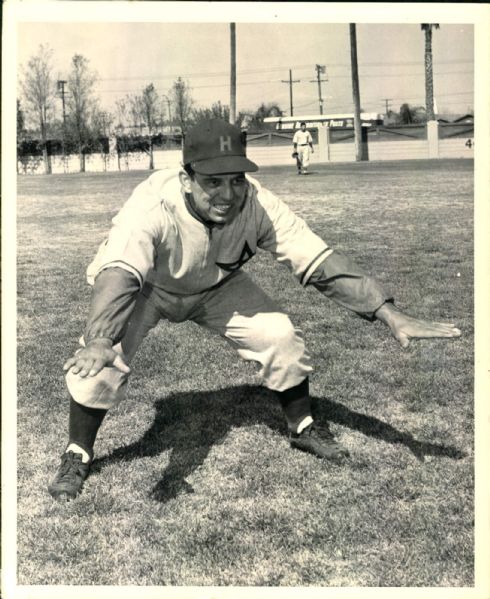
87, 177, 167, 287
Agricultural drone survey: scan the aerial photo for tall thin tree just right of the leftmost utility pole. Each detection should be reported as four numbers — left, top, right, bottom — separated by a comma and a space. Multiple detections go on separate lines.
67, 54, 97, 173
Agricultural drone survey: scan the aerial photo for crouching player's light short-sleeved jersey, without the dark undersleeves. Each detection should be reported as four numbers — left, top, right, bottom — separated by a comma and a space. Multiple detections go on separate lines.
87, 170, 332, 295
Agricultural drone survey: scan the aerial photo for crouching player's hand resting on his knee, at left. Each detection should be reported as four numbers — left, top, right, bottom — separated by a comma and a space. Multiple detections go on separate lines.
63, 339, 131, 377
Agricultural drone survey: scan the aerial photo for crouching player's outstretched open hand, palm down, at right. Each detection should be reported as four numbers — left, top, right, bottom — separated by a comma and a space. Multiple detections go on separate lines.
375, 302, 461, 348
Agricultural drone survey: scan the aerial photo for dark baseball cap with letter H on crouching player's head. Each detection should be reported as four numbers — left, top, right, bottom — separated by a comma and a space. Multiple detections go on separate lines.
183, 119, 259, 175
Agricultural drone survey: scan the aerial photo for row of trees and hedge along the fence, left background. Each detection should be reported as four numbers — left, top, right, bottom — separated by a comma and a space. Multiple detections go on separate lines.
17, 44, 282, 174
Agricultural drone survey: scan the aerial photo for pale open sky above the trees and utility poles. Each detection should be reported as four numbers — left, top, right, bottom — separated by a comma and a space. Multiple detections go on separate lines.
17, 2, 474, 124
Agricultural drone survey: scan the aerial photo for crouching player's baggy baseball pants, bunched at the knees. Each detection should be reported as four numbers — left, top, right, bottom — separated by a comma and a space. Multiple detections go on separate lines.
66, 271, 312, 410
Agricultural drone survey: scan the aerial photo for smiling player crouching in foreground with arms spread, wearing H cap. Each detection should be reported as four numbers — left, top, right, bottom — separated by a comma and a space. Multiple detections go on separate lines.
49, 119, 460, 501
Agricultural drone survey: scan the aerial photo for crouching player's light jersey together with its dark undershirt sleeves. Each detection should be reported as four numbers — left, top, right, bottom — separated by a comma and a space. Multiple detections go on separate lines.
84, 171, 391, 341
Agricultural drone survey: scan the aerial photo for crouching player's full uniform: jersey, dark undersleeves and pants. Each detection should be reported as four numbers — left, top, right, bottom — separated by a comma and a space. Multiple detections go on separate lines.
67, 170, 389, 409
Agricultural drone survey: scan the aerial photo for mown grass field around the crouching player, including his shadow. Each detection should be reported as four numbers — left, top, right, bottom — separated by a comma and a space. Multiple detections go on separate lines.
18, 160, 474, 587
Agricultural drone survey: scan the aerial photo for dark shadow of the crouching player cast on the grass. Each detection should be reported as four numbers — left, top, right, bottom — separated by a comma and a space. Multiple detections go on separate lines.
92, 386, 465, 502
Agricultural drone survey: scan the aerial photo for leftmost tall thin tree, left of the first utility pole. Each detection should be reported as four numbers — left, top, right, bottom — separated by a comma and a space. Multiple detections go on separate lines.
21, 44, 56, 174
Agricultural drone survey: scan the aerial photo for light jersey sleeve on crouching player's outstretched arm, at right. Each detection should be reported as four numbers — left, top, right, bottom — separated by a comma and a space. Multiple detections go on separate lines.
256, 182, 333, 285
